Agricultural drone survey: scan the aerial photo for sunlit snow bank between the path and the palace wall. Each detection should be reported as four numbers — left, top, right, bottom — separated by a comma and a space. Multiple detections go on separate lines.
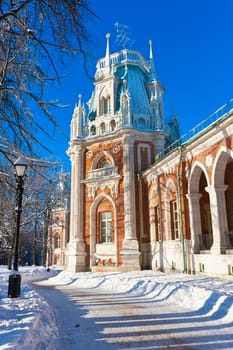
48, 271, 233, 321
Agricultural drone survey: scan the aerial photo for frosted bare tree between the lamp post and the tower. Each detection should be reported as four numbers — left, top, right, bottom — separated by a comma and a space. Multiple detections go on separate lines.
21, 163, 63, 266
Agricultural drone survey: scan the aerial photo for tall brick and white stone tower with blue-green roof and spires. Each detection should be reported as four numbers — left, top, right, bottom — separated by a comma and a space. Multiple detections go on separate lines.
66, 34, 167, 272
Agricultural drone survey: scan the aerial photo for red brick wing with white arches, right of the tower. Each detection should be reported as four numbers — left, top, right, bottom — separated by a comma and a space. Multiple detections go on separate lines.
142, 111, 233, 274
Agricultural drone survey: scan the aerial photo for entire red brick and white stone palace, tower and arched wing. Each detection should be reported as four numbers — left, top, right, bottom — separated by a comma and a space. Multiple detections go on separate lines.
62, 34, 233, 274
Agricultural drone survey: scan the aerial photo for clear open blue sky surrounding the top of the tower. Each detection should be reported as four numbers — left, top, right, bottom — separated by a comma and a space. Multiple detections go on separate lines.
44, 0, 233, 171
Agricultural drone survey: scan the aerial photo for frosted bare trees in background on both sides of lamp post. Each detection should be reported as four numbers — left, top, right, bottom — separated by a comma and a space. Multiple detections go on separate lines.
0, 150, 68, 269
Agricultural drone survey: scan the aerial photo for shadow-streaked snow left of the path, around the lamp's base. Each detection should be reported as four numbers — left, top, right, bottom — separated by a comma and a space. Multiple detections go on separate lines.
0, 267, 58, 350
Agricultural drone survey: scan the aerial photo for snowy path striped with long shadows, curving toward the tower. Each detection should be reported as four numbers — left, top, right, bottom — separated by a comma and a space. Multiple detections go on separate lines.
33, 281, 233, 350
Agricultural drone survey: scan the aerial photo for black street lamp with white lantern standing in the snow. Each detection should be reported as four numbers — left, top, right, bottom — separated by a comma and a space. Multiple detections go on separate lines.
8, 157, 27, 298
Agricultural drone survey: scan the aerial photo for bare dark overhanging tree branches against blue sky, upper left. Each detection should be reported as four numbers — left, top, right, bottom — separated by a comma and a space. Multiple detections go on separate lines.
0, 0, 96, 156
